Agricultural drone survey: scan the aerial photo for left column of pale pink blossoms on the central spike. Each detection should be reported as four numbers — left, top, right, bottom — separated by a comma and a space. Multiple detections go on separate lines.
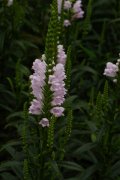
29, 59, 46, 114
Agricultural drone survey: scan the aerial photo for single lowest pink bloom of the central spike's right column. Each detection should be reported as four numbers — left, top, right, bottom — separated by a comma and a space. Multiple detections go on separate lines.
50, 107, 64, 117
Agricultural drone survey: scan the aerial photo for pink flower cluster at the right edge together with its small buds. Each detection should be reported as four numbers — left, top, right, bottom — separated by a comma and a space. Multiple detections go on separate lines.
103, 54, 120, 82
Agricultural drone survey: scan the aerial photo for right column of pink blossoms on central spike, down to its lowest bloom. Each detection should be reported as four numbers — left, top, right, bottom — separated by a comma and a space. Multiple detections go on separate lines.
49, 63, 66, 117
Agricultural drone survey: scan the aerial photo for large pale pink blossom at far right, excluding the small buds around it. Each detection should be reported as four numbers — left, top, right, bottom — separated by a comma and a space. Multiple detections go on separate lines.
103, 62, 118, 77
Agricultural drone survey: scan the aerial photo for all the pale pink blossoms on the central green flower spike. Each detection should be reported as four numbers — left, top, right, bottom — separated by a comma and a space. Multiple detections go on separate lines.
29, 45, 67, 127
